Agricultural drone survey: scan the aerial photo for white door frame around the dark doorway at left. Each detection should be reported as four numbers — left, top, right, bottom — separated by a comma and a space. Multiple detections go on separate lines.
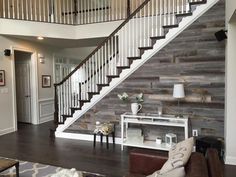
11, 46, 39, 131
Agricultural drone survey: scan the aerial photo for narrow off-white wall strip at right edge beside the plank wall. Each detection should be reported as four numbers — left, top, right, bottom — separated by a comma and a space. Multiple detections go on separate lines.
225, 23, 236, 165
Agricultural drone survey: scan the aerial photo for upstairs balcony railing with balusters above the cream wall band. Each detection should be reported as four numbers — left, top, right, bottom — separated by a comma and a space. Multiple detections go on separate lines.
0, 0, 147, 25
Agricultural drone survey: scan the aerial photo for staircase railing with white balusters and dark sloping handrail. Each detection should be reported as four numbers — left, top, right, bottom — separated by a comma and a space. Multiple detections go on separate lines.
54, 0, 193, 123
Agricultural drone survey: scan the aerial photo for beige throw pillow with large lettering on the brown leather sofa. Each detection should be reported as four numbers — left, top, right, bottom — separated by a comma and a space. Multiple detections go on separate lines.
160, 137, 193, 174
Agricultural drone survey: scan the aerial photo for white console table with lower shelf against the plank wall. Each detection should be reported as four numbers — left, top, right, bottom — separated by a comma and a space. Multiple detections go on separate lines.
121, 113, 188, 151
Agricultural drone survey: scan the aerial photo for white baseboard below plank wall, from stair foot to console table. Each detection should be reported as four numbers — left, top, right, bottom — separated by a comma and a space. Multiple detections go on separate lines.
55, 132, 121, 144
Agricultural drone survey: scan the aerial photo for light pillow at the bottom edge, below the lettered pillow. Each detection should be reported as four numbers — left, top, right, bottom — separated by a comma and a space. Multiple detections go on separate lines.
147, 167, 185, 177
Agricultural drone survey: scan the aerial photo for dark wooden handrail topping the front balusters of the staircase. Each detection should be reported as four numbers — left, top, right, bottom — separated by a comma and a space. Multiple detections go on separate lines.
54, 0, 150, 87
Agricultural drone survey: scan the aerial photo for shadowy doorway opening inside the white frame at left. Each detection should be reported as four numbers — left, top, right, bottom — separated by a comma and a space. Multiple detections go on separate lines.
14, 50, 32, 123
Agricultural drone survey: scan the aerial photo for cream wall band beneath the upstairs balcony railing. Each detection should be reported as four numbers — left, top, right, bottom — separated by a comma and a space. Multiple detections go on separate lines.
0, 19, 122, 39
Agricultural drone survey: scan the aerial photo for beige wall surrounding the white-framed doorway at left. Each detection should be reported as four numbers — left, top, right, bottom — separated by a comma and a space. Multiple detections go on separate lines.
0, 36, 56, 135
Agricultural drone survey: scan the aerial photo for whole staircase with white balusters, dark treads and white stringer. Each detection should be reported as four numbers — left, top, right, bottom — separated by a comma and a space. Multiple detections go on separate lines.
55, 0, 218, 137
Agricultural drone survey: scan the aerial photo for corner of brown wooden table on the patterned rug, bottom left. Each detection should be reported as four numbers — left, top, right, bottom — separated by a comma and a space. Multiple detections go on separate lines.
0, 157, 19, 177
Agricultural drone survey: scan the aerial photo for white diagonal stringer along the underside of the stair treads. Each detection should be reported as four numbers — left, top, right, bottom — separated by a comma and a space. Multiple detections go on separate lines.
55, 0, 219, 137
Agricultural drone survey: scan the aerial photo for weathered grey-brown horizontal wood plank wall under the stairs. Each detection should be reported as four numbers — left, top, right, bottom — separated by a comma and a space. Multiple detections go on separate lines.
66, 1, 225, 139
